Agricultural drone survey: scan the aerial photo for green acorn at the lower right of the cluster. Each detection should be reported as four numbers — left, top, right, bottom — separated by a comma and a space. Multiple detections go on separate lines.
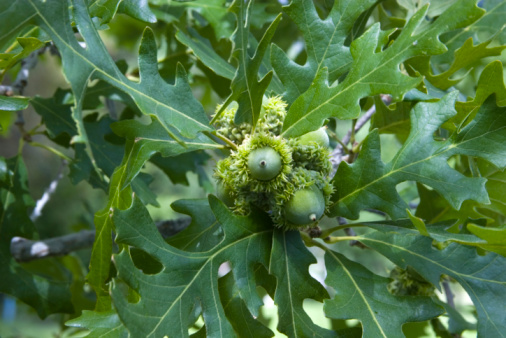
285, 185, 325, 225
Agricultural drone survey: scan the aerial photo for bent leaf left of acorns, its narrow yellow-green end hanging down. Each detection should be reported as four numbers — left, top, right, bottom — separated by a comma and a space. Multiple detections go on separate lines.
88, 118, 221, 310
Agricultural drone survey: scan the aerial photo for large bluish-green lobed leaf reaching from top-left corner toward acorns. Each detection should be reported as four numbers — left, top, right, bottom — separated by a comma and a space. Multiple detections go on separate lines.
19, 0, 212, 169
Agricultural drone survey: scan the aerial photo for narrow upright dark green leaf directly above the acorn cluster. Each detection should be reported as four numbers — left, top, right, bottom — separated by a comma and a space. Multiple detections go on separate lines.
213, 0, 281, 128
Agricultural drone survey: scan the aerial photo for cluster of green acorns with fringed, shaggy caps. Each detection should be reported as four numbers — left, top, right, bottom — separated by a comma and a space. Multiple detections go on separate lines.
214, 96, 333, 229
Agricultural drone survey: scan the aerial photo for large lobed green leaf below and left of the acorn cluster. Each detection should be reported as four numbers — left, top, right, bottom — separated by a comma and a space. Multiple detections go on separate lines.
112, 197, 272, 337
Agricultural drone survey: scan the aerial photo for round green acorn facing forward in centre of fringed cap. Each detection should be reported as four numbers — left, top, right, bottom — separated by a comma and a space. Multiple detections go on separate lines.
248, 147, 282, 181
